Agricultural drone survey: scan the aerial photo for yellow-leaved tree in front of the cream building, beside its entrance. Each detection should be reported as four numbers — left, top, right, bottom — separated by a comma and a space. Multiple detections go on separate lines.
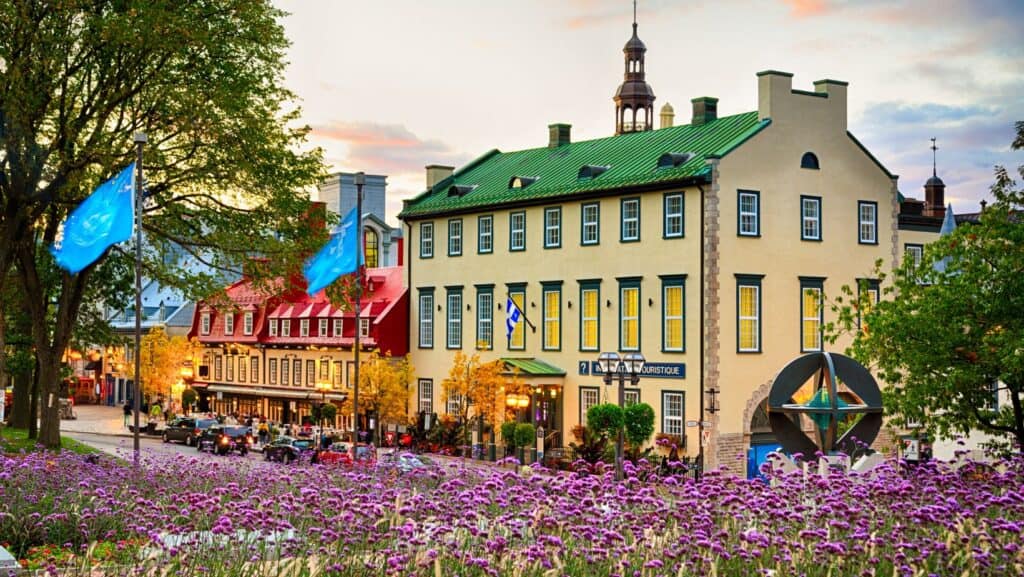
441, 351, 505, 445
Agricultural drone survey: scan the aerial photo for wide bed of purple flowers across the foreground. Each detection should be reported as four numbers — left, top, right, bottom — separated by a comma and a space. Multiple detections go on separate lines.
0, 453, 1024, 577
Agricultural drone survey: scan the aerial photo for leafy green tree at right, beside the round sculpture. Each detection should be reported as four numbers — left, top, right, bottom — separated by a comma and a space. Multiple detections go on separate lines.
833, 122, 1024, 455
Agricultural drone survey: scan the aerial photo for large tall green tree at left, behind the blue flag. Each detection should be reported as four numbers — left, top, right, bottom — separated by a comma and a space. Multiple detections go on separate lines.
0, 0, 323, 447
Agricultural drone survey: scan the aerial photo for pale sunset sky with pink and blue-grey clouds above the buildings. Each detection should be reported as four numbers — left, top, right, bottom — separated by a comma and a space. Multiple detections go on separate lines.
275, 0, 1024, 223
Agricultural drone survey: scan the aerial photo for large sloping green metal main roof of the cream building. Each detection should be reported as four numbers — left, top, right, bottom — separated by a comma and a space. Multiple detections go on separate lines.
398, 112, 771, 219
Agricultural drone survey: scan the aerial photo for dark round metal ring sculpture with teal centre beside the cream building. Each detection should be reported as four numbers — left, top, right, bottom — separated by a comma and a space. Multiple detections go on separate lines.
768, 353, 882, 458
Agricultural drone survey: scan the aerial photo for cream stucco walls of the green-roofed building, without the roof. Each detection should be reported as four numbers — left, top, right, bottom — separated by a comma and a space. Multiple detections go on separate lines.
403, 71, 902, 472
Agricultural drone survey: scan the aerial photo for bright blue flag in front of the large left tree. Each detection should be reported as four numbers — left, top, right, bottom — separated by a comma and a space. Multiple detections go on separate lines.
50, 163, 135, 275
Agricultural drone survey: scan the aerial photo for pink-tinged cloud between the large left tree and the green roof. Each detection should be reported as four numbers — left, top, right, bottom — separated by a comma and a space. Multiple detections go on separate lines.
310, 121, 468, 181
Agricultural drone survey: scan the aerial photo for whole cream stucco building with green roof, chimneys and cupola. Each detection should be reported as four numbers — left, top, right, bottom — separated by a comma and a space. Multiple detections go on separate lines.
399, 21, 899, 472
